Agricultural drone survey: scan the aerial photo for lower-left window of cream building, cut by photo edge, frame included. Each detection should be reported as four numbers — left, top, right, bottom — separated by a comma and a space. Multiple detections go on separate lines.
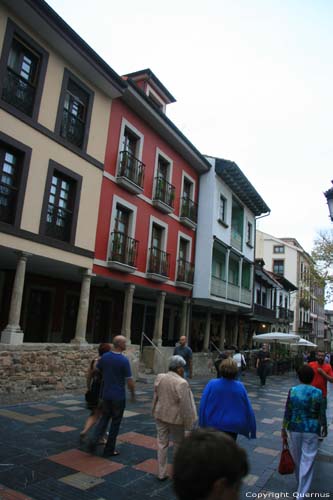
0, 133, 31, 226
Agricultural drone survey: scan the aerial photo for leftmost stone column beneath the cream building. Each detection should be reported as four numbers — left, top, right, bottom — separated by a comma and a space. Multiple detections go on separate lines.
1, 252, 31, 345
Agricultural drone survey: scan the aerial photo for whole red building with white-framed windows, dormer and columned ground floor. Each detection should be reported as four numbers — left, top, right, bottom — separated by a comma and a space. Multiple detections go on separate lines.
93, 69, 210, 346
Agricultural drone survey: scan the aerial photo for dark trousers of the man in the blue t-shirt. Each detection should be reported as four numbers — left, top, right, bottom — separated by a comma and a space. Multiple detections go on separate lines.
92, 400, 125, 455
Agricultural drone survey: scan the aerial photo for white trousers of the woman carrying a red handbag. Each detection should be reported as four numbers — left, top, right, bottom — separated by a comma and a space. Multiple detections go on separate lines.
289, 432, 318, 494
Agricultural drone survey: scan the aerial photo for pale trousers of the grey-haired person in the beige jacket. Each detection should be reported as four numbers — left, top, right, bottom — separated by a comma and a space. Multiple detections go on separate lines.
156, 420, 185, 479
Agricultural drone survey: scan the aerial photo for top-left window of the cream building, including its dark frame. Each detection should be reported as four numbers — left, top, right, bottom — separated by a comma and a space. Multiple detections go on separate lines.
0, 20, 48, 119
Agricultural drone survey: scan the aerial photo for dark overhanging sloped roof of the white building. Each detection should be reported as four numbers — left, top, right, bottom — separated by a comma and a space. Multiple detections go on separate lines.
215, 158, 271, 217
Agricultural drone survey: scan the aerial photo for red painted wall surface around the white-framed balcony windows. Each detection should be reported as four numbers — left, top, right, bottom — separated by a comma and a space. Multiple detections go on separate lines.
94, 99, 199, 296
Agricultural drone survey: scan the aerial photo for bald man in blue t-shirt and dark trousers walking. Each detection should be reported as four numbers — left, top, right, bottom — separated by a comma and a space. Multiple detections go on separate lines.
89, 335, 135, 457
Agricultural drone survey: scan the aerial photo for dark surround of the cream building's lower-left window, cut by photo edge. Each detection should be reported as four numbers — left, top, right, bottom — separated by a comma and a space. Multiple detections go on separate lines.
0, 132, 32, 228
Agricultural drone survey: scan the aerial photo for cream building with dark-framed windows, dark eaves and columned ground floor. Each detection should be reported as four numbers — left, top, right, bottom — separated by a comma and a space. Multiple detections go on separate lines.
0, 0, 126, 344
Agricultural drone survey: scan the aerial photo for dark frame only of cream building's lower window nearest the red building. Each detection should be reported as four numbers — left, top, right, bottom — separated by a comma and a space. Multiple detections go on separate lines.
39, 160, 82, 246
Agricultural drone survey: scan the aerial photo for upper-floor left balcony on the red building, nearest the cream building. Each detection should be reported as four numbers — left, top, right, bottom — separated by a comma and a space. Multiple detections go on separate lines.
117, 151, 145, 194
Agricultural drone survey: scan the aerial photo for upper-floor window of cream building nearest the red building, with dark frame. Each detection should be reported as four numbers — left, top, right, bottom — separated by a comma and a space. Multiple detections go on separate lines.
56, 70, 93, 150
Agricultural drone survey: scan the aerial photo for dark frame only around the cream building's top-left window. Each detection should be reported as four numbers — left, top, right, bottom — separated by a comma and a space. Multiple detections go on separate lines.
0, 19, 49, 122
